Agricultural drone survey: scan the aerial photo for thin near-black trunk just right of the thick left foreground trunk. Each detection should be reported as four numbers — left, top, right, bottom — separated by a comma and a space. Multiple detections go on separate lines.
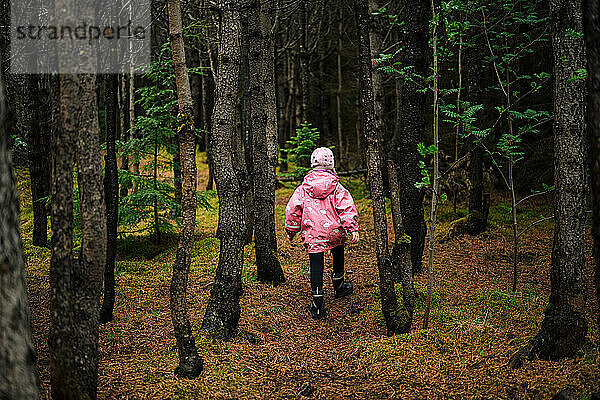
100, 74, 119, 323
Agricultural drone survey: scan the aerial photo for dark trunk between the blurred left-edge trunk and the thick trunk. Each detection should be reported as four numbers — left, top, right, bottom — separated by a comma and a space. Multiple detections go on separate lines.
26, 75, 53, 247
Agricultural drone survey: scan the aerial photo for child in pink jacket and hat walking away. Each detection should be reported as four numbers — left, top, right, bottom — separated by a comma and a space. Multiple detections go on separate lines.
285, 147, 359, 319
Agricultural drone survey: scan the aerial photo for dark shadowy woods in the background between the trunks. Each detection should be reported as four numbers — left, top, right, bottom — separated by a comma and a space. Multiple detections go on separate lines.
0, 0, 553, 194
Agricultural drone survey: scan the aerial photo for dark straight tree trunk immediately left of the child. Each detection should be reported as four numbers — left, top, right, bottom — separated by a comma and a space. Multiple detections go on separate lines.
248, 0, 285, 285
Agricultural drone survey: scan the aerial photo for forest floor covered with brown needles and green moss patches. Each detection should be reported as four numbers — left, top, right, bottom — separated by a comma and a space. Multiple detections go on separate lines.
19, 152, 600, 399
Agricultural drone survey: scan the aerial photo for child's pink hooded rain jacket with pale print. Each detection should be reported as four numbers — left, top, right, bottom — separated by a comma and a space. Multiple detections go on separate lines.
285, 170, 358, 253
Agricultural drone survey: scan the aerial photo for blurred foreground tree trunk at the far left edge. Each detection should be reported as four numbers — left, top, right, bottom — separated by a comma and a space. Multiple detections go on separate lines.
0, 66, 40, 400
